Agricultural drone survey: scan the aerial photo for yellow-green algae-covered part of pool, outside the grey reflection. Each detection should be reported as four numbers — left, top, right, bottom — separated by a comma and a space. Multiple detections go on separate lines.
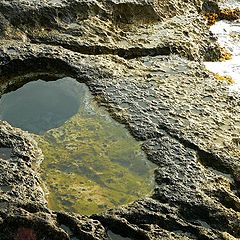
0, 78, 154, 215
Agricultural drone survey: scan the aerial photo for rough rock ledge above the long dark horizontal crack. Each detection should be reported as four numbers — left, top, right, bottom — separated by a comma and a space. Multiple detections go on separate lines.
0, 0, 220, 60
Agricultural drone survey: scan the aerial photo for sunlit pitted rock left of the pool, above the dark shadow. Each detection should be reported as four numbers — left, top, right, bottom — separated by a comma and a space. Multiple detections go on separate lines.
0, 122, 46, 205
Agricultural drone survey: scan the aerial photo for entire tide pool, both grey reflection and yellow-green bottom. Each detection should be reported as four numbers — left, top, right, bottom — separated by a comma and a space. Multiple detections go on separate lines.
0, 78, 154, 215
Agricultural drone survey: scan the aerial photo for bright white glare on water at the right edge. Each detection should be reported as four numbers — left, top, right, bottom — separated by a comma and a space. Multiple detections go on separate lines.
205, 21, 240, 91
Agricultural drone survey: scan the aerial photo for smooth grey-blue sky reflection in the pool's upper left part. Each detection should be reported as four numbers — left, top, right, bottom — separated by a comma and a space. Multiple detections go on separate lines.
0, 78, 81, 134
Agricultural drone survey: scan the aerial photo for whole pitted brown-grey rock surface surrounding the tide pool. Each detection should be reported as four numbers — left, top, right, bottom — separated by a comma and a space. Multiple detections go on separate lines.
0, 0, 240, 240
